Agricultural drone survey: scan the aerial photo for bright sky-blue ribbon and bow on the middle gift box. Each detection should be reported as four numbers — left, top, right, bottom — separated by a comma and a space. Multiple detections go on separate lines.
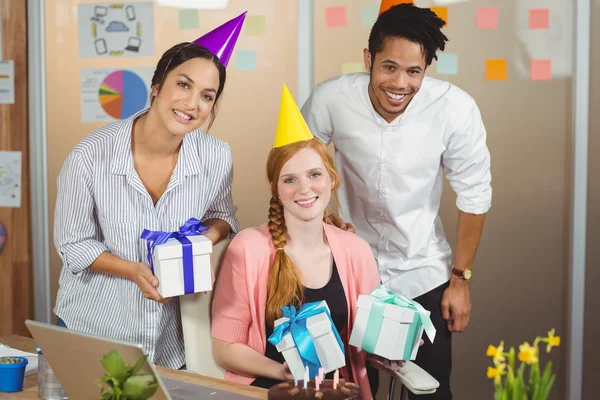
269, 301, 344, 379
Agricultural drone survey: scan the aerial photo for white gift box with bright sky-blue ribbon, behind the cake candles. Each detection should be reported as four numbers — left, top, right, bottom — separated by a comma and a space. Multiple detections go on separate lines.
268, 301, 346, 380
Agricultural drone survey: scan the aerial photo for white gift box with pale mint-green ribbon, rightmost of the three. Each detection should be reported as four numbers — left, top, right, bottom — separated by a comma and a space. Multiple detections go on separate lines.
349, 285, 435, 360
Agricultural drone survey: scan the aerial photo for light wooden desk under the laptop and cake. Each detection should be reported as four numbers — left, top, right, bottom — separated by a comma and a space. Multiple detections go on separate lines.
0, 336, 267, 400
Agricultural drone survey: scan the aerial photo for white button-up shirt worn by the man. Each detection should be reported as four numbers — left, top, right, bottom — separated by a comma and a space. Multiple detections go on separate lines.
302, 73, 492, 298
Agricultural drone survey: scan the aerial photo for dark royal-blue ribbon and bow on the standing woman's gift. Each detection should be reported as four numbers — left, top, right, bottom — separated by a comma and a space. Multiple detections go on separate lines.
140, 218, 208, 294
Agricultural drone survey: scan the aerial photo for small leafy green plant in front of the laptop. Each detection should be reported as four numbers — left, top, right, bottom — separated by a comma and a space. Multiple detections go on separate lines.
98, 350, 158, 400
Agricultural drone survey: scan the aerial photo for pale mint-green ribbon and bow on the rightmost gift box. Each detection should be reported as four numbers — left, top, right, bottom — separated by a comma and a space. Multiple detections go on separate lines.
361, 285, 435, 354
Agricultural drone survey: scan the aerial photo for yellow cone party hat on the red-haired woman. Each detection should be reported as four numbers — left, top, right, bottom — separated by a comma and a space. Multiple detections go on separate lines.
273, 84, 313, 147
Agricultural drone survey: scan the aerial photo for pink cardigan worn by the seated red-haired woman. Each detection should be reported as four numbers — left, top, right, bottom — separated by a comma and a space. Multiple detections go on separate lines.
212, 224, 380, 399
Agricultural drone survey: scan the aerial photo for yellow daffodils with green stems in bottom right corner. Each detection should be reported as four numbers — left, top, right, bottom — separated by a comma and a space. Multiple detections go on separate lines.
487, 329, 560, 400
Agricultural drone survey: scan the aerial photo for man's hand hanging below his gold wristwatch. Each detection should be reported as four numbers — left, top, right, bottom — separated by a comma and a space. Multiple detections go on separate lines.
442, 276, 471, 332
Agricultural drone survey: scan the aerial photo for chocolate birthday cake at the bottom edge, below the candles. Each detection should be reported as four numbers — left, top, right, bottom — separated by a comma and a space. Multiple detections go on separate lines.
268, 379, 362, 400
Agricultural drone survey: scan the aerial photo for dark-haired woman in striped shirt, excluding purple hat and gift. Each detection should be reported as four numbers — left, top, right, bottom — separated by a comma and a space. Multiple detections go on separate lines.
54, 43, 239, 369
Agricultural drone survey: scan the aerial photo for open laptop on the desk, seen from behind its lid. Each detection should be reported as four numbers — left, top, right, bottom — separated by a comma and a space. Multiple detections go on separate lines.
25, 320, 251, 400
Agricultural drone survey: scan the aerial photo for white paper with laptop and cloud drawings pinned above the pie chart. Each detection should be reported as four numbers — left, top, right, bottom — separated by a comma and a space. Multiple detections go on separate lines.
77, 2, 154, 58
